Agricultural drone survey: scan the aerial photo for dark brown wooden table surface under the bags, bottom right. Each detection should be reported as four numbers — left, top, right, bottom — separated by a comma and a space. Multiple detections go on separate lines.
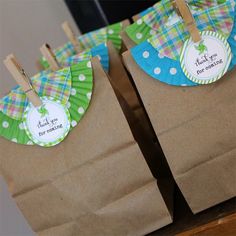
149, 184, 236, 236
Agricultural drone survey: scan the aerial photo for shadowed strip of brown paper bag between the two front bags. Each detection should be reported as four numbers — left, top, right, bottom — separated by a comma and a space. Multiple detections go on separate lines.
108, 42, 174, 212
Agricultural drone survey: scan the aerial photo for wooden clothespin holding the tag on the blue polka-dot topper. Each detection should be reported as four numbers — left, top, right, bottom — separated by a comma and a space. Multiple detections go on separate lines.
174, 0, 201, 43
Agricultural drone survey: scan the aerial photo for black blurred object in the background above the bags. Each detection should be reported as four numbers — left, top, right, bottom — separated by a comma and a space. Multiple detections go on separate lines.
65, 0, 158, 33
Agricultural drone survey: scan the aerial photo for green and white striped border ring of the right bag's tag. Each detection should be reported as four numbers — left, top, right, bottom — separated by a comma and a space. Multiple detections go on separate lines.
180, 31, 232, 84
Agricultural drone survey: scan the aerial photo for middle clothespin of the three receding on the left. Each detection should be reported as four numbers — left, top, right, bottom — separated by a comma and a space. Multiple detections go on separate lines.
40, 44, 61, 71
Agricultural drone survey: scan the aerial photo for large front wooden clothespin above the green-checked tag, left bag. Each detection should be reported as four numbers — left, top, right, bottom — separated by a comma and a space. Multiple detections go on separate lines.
4, 54, 42, 107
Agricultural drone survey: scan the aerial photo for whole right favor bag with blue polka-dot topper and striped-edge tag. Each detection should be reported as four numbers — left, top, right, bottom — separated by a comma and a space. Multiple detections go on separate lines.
123, 1, 236, 213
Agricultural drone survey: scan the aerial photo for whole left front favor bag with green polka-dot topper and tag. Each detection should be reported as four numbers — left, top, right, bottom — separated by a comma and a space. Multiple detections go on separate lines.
0, 56, 171, 236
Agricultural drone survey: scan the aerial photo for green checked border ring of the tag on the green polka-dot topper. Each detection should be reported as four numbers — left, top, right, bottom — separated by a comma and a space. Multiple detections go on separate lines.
23, 97, 70, 147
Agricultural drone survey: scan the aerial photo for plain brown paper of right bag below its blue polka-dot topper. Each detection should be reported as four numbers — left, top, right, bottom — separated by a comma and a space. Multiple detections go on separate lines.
123, 52, 236, 213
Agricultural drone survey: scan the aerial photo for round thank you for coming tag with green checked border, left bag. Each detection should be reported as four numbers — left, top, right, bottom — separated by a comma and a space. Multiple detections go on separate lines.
23, 97, 70, 147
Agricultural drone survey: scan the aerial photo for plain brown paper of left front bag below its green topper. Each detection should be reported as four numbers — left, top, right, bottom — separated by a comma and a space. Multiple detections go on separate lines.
0, 59, 171, 236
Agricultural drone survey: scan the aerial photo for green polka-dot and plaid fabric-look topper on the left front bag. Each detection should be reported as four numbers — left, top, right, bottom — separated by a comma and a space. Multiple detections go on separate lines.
0, 60, 93, 145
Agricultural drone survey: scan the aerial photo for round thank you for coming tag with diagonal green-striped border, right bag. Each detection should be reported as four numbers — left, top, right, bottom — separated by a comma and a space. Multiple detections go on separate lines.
180, 31, 232, 84
